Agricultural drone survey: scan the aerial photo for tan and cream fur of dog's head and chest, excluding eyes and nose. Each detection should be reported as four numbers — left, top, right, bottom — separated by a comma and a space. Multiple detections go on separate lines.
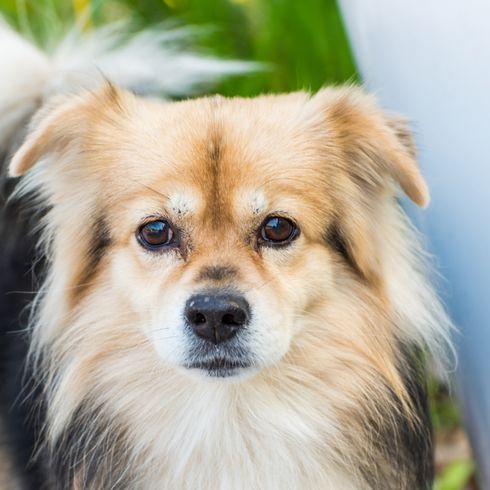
11, 87, 449, 490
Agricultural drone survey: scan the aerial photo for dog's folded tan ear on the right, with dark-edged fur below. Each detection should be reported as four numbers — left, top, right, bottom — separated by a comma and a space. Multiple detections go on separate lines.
311, 87, 429, 284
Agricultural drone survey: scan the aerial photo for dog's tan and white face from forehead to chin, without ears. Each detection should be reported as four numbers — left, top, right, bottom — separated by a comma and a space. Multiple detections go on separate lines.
104, 96, 338, 377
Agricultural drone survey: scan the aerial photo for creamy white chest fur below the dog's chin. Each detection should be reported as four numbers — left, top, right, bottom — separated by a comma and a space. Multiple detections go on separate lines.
118, 381, 362, 490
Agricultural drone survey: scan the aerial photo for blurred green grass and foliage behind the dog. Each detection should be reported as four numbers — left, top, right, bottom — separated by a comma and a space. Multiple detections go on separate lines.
0, 0, 478, 490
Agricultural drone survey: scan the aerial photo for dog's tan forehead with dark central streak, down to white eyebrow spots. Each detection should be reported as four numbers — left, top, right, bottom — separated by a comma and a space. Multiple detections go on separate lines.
102, 93, 334, 222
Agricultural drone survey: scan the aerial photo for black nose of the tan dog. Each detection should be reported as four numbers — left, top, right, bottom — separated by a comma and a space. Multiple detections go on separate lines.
184, 291, 250, 344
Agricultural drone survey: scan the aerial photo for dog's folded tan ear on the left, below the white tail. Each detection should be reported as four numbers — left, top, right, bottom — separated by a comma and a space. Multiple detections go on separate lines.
9, 83, 120, 177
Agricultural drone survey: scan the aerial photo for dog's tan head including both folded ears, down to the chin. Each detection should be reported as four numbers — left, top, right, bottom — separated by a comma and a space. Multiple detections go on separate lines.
12, 88, 427, 378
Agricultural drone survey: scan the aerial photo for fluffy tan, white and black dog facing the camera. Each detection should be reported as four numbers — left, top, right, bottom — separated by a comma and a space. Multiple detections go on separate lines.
0, 17, 451, 490
